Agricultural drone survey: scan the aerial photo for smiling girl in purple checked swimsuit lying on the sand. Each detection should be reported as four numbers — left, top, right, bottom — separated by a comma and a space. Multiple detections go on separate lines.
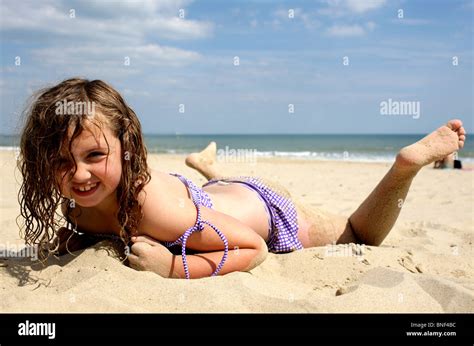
18, 78, 466, 278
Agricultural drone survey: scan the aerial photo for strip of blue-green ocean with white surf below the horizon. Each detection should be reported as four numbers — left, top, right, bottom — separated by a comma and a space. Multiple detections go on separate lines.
0, 134, 474, 163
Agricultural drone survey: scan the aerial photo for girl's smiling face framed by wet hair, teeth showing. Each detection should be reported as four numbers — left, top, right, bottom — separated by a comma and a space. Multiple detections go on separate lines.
57, 124, 122, 209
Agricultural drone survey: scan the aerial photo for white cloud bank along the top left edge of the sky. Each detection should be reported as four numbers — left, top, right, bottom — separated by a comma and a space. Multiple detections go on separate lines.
0, 0, 213, 42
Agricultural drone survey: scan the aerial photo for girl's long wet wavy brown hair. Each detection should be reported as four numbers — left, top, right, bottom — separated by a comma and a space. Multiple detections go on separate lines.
18, 78, 150, 254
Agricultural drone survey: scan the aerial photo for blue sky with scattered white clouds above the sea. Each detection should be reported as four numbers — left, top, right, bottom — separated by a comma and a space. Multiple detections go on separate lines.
0, 0, 474, 134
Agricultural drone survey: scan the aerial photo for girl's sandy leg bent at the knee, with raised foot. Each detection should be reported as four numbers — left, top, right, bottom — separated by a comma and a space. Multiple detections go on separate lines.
297, 120, 466, 247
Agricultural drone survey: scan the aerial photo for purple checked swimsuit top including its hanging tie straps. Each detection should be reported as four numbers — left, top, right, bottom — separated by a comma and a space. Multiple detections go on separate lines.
163, 173, 229, 279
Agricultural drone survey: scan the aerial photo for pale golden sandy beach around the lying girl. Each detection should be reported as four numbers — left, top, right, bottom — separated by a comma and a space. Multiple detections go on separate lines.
0, 151, 474, 312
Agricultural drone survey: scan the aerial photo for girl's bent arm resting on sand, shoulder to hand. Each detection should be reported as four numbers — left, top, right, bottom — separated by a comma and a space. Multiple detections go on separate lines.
136, 195, 268, 278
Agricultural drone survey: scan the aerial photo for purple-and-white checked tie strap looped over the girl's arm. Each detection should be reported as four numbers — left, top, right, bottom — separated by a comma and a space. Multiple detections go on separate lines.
168, 173, 229, 279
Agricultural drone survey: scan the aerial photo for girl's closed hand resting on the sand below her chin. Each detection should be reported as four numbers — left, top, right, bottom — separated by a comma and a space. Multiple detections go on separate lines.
128, 235, 174, 278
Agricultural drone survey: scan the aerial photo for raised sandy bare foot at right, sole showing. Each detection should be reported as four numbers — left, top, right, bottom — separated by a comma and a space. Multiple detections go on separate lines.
395, 119, 466, 173
